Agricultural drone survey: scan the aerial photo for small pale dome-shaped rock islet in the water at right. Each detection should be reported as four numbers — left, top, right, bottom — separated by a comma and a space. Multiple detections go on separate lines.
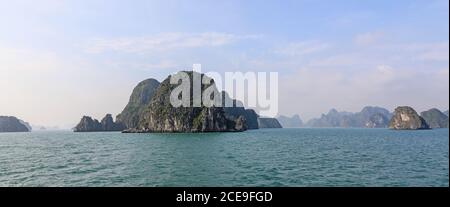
389, 106, 430, 130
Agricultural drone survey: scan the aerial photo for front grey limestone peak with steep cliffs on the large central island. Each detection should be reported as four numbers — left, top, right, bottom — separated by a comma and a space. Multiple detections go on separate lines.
134, 72, 247, 132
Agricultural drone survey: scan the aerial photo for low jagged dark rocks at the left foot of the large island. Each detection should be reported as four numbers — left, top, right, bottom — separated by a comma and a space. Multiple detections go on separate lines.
74, 114, 125, 132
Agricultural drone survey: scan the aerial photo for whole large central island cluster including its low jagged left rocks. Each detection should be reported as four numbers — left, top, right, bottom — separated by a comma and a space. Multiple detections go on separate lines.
74, 71, 281, 133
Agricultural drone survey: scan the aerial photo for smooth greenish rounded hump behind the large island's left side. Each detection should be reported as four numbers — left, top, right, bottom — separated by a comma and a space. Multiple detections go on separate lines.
116, 79, 160, 128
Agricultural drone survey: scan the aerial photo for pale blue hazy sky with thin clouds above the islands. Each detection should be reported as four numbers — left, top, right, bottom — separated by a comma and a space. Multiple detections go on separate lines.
0, 0, 449, 127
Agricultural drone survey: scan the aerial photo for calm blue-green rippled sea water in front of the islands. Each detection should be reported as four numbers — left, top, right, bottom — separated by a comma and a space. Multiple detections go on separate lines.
0, 129, 449, 186
